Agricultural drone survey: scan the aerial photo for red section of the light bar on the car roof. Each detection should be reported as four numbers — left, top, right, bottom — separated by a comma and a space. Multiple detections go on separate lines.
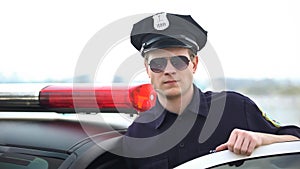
39, 84, 156, 112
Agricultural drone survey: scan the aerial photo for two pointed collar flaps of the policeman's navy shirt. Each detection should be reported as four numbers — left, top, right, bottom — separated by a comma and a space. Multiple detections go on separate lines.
150, 84, 208, 129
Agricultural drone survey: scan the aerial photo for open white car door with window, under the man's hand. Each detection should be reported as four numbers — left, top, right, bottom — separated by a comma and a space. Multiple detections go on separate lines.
176, 141, 300, 169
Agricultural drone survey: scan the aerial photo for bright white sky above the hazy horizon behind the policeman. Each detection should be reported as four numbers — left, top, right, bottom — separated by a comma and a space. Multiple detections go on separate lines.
0, 0, 300, 81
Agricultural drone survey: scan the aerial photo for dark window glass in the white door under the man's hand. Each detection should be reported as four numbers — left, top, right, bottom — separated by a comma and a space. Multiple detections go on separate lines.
211, 153, 300, 169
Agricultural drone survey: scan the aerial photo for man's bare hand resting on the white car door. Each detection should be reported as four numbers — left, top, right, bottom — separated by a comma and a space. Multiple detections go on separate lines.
216, 129, 262, 155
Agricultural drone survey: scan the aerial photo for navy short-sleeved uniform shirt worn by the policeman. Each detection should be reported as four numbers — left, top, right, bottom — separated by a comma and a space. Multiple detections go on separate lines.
123, 86, 300, 169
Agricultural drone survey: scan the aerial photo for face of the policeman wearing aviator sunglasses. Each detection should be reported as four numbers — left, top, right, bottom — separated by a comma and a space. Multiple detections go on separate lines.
145, 48, 198, 98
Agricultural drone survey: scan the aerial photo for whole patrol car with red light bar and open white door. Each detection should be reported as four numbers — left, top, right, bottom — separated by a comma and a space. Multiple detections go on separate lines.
0, 84, 300, 169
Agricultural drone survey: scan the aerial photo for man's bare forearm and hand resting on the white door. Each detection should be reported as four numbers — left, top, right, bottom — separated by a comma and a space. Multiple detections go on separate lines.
216, 129, 300, 155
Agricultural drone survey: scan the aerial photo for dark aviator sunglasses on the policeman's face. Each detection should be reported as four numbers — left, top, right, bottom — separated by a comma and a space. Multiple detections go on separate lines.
149, 56, 190, 73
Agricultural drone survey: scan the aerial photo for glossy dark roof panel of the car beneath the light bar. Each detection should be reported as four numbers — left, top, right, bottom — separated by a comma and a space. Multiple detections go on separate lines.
0, 115, 127, 153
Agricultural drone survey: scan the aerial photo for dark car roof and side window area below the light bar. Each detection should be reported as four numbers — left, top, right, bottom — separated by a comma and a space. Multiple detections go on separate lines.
0, 112, 126, 169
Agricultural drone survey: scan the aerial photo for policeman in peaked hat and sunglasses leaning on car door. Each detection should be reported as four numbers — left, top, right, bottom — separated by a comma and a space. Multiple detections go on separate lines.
123, 13, 300, 169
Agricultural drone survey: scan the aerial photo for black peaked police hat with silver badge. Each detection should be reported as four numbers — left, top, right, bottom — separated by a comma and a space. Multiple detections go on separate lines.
130, 13, 207, 56
